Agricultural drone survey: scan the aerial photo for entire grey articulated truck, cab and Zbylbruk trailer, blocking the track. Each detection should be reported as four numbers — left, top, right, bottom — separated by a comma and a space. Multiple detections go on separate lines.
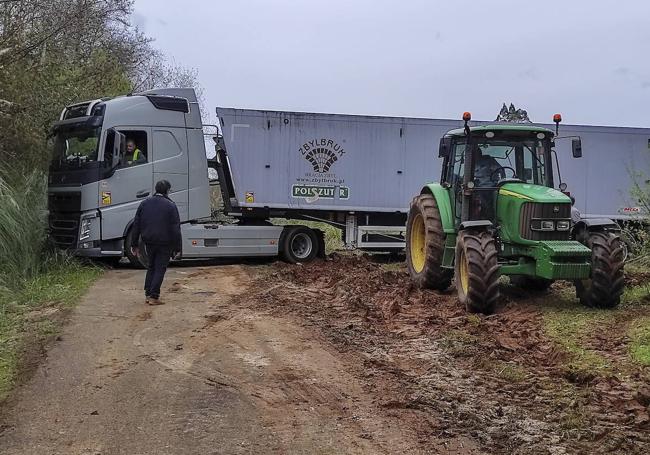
48, 89, 650, 264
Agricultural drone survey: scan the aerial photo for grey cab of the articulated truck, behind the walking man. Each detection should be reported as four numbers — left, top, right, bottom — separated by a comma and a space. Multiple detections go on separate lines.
48, 89, 210, 262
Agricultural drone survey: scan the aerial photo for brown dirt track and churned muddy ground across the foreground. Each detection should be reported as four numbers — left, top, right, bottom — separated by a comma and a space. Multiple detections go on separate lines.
0, 255, 650, 455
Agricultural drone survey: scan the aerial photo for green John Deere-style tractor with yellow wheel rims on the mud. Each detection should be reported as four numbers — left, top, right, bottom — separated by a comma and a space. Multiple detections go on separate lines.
406, 112, 625, 313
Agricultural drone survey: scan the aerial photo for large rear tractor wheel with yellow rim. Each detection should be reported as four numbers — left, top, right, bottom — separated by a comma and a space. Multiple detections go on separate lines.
406, 193, 453, 291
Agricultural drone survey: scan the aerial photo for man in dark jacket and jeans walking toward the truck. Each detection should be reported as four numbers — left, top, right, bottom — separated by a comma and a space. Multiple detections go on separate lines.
132, 180, 181, 305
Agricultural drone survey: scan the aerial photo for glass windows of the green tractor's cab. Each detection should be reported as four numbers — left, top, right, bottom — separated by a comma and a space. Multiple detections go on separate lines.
452, 131, 552, 188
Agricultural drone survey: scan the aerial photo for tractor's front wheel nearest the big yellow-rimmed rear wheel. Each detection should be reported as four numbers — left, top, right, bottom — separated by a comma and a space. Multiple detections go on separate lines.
454, 230, 500, 314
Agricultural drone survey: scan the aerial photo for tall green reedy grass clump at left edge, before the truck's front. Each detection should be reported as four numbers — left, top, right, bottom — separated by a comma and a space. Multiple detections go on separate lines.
0, 169, 47, 289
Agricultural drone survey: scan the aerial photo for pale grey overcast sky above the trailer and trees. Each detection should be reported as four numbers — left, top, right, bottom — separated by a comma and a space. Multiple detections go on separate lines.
133, 0, 650, 127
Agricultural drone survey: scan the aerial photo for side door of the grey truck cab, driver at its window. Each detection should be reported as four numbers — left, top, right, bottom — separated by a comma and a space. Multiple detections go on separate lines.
99, 127, 153, 240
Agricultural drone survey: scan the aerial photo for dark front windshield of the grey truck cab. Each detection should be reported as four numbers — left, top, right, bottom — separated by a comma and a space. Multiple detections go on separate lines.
51, 128, 101, 168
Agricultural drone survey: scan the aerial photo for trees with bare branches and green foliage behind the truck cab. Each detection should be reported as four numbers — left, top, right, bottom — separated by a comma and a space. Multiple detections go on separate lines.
0, 0, 202, 170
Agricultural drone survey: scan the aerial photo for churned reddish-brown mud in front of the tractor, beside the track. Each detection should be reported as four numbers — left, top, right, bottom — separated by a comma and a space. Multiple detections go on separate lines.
240, 255, 650, 454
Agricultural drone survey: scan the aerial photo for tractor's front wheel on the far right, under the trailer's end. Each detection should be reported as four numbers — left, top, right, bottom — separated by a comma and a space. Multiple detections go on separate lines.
575, 232, 625, 308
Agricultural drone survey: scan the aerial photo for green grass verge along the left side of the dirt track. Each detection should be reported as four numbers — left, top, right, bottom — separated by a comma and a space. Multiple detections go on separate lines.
0, 258, 102, 401
